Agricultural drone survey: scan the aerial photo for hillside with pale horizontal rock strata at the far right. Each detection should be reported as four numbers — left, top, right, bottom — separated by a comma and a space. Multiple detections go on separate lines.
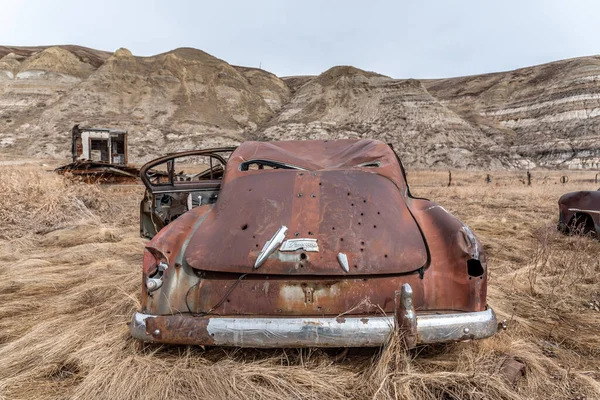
424, 56, 600, 168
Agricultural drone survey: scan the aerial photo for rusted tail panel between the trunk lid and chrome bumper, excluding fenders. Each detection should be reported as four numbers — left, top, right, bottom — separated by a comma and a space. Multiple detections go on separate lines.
186, 274, 424, 315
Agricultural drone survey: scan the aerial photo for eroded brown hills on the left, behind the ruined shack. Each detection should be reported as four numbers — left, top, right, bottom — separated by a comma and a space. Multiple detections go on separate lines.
0, 47, 289, 162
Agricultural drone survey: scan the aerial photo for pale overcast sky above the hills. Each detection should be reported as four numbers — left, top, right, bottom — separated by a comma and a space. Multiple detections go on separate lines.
0, 0, 600, 78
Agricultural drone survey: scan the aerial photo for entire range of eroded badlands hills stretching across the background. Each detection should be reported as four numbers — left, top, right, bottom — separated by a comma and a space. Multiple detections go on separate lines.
0, 46, 600, 168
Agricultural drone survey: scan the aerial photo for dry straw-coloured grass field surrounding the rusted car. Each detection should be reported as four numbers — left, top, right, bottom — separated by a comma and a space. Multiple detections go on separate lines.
0, 165, 600, 400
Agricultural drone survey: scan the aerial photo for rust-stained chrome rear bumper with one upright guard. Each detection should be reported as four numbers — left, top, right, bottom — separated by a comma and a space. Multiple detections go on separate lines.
130, 285, 498, 347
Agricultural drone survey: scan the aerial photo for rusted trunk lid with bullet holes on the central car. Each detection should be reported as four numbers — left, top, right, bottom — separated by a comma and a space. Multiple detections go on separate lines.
185, 169, 428, 275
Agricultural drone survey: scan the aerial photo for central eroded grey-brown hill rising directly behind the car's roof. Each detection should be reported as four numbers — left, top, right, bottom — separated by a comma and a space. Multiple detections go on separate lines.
257, 67, 500, 167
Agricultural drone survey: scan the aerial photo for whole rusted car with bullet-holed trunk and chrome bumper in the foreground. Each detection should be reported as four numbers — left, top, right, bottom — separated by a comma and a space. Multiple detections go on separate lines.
130, 140, 497, 347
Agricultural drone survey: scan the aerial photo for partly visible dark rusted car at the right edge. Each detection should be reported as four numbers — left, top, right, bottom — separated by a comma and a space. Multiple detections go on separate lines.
558, 190, 600, 236
